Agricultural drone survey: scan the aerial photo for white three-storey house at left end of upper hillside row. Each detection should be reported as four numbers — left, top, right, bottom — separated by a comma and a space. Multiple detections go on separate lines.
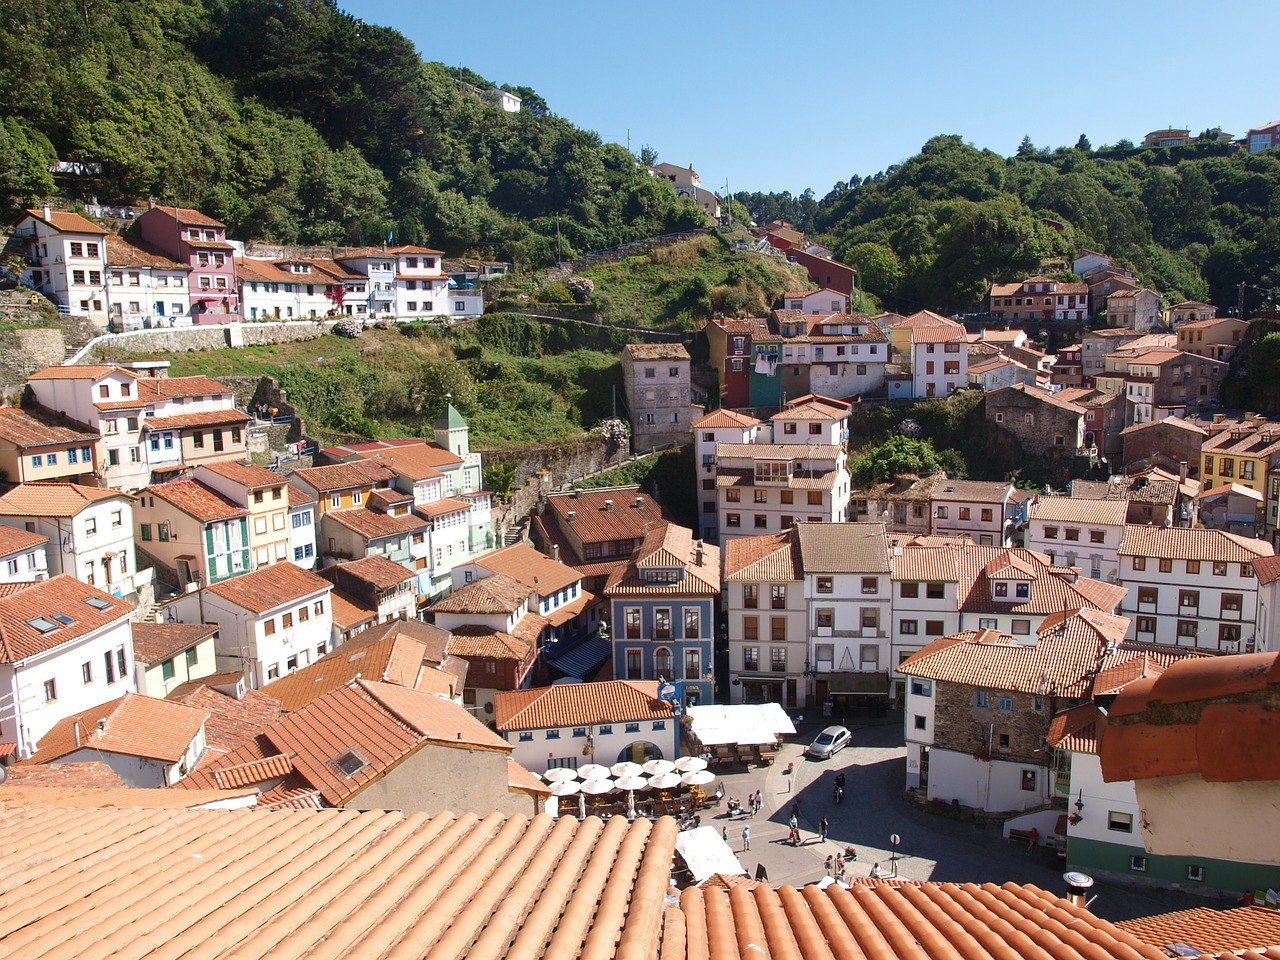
13, 206, 108, 325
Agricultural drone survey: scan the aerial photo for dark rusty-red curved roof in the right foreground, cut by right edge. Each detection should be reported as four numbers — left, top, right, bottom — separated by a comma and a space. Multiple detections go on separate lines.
1100, 653, 1280, 783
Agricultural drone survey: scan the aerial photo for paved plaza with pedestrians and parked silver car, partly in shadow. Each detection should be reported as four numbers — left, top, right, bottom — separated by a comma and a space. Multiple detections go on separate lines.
701, 712, 1217, 920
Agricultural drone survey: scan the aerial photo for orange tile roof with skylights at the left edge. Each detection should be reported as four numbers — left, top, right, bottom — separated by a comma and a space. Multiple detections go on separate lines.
0, 573, 133, 663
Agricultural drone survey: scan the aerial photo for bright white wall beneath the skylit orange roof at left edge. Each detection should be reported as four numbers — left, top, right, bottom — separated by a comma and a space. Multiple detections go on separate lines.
0, 593, 134, 758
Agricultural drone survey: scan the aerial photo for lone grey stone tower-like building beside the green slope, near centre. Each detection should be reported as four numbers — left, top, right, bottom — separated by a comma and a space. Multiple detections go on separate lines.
622, 343, 703, 451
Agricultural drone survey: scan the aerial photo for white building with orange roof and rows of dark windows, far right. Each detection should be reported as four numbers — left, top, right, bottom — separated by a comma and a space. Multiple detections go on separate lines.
1119, 525, 1275, 653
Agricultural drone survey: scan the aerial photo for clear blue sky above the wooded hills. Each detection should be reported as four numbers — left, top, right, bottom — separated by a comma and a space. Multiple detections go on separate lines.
339, 0, 1280, 197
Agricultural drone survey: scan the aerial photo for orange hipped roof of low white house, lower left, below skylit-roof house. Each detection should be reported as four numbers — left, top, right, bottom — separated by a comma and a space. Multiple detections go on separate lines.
27, 694, 209, 763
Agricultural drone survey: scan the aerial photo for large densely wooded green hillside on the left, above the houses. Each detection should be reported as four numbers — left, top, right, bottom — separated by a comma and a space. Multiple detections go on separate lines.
0, 0, 703, 265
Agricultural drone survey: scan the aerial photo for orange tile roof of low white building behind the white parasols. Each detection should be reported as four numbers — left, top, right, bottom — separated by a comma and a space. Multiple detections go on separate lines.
494, 680, 672, 730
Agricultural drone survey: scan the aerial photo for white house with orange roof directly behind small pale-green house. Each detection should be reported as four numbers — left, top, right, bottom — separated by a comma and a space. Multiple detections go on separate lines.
166, 563, 333, 689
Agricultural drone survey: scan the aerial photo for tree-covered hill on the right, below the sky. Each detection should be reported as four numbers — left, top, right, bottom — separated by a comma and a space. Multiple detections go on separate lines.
736, 136, 1280, 317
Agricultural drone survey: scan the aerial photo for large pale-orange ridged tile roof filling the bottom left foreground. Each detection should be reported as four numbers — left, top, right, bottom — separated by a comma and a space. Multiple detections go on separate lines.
0, 791, 675, 960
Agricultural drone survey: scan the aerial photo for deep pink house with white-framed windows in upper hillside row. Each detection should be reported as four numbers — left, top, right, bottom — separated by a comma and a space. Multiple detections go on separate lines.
138, 204, 241, 324
